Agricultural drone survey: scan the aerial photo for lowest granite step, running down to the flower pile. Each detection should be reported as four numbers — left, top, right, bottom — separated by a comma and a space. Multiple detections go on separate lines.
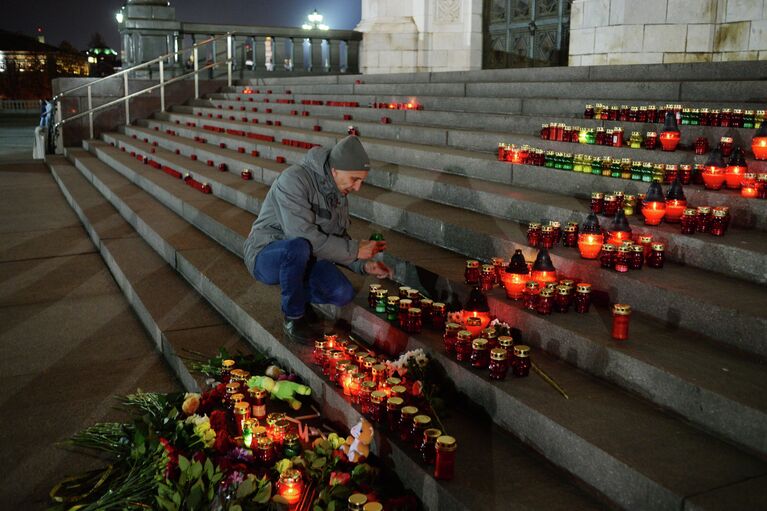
49, 156, 250, 392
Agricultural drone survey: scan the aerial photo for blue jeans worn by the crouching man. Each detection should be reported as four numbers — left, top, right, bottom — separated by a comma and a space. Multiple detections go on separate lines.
253, 238, 354, 319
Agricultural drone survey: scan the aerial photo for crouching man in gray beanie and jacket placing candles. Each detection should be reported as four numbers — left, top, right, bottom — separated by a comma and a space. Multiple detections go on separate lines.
245, 136, 391, 343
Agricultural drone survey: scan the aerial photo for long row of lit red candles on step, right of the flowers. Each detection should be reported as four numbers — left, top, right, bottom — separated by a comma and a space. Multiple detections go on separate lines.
313, 334, 457, 479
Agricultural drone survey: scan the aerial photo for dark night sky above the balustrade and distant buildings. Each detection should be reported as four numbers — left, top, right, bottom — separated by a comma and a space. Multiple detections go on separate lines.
0, 0, 360, 51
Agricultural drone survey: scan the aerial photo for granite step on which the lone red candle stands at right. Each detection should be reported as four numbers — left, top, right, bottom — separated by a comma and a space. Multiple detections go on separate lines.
97, 135, 767, 460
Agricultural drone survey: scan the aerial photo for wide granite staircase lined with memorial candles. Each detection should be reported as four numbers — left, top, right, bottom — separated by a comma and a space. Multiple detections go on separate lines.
49, 63, 767, 510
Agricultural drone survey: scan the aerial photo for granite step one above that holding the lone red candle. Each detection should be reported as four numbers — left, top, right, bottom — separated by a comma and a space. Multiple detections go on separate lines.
118, 121, 767, 355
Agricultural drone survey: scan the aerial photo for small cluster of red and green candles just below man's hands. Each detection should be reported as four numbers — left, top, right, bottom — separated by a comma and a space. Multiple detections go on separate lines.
368, 284, 447, 334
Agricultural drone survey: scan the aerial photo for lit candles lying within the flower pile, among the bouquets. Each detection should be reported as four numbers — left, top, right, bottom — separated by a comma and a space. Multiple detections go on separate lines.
220, 360, 304, 504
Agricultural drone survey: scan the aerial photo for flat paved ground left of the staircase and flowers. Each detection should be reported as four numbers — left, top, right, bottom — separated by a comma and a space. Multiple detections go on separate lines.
0, 161, 180, 510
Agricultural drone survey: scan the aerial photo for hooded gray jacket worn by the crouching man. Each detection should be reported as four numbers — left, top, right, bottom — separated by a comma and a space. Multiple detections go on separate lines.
244, 147, 365, 274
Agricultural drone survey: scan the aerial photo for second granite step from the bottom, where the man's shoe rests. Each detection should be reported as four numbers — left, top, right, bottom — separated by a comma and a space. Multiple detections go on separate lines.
68, 143, 607, 510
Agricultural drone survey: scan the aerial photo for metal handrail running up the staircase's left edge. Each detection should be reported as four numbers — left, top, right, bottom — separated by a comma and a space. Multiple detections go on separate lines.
53, 32, 234, 150
